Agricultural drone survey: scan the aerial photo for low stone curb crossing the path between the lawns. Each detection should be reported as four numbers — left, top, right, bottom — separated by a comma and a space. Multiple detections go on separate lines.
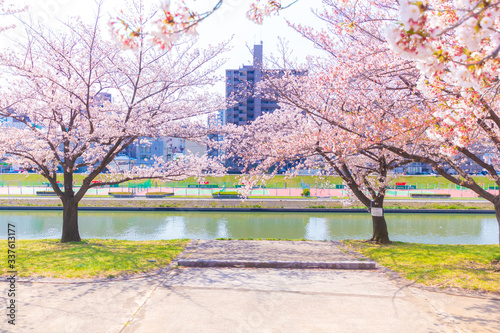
177, 259, 377, 269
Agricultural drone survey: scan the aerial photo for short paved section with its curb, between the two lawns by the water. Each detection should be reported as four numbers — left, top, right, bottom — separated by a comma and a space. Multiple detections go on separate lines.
178, 240, 376, 269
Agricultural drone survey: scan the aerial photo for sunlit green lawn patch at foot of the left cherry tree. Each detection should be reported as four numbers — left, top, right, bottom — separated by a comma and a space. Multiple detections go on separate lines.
0, 239, 189, 278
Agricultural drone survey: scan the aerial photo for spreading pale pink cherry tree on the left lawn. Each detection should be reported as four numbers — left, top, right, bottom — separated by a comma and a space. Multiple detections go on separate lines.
0, 8, 226, 242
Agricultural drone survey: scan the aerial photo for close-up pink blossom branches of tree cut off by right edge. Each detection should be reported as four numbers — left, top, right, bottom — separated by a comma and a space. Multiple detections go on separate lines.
366, 0, 500, 244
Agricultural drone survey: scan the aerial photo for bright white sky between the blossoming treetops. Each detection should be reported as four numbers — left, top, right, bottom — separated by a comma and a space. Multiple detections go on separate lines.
0, 0, 321, 94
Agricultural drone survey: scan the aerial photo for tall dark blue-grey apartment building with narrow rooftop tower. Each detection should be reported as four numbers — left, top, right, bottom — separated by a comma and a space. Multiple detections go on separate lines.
224, 44, 278, 125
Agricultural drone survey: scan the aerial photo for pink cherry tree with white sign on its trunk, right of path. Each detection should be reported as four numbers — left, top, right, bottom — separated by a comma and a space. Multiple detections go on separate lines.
224, 1, 429, 243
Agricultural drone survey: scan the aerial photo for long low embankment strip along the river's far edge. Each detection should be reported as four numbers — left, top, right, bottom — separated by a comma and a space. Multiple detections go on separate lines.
0, 197, 494, 213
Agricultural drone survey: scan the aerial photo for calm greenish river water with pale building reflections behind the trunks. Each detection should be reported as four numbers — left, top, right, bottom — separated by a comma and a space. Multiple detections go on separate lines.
0, 211, 498, 244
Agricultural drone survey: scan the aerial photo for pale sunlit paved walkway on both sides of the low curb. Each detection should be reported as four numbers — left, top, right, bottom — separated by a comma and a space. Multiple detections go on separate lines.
0, 241, 500, 333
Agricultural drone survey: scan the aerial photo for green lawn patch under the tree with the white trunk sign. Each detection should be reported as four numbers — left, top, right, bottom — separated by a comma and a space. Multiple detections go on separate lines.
344, 241, 500, 293
